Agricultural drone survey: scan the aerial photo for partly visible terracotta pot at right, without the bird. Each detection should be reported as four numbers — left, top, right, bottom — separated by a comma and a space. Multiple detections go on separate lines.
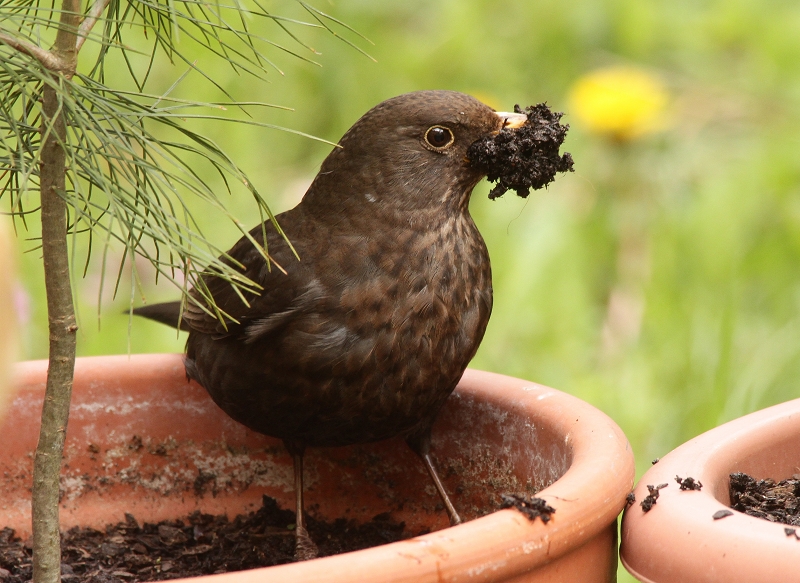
621, 399, 800, 583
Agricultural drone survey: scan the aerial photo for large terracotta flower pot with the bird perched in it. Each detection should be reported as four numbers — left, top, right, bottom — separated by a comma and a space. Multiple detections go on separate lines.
0, 355, 634, 583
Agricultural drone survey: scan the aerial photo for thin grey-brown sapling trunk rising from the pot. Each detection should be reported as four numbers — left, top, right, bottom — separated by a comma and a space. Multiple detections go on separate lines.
32, 0, 80, 583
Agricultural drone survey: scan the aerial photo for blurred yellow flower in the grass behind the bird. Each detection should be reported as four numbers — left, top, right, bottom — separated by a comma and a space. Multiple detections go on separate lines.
570, 67, 667, 141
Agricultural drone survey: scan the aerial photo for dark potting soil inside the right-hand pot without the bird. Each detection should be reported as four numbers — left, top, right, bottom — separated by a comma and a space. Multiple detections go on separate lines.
729, 472, 800, 535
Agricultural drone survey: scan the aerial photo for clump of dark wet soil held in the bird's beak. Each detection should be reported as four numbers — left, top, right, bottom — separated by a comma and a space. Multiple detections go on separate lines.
467, 103, 573, 200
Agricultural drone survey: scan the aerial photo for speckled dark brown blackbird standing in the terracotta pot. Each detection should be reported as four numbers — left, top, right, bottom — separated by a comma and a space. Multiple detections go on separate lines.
134, 91, 527, 559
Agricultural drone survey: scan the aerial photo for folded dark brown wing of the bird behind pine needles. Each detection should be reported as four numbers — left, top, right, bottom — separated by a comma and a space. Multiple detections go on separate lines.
183, 209, 316, 339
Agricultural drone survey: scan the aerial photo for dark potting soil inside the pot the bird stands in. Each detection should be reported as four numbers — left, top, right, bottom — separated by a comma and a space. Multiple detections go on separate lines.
0, 496, 425, 583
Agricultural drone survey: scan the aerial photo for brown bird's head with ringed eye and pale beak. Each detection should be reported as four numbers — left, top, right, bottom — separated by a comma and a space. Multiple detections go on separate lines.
306, 91, 527, 218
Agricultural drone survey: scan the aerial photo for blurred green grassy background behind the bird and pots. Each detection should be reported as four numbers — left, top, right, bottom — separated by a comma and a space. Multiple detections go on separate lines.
10, 0, 800, 580
